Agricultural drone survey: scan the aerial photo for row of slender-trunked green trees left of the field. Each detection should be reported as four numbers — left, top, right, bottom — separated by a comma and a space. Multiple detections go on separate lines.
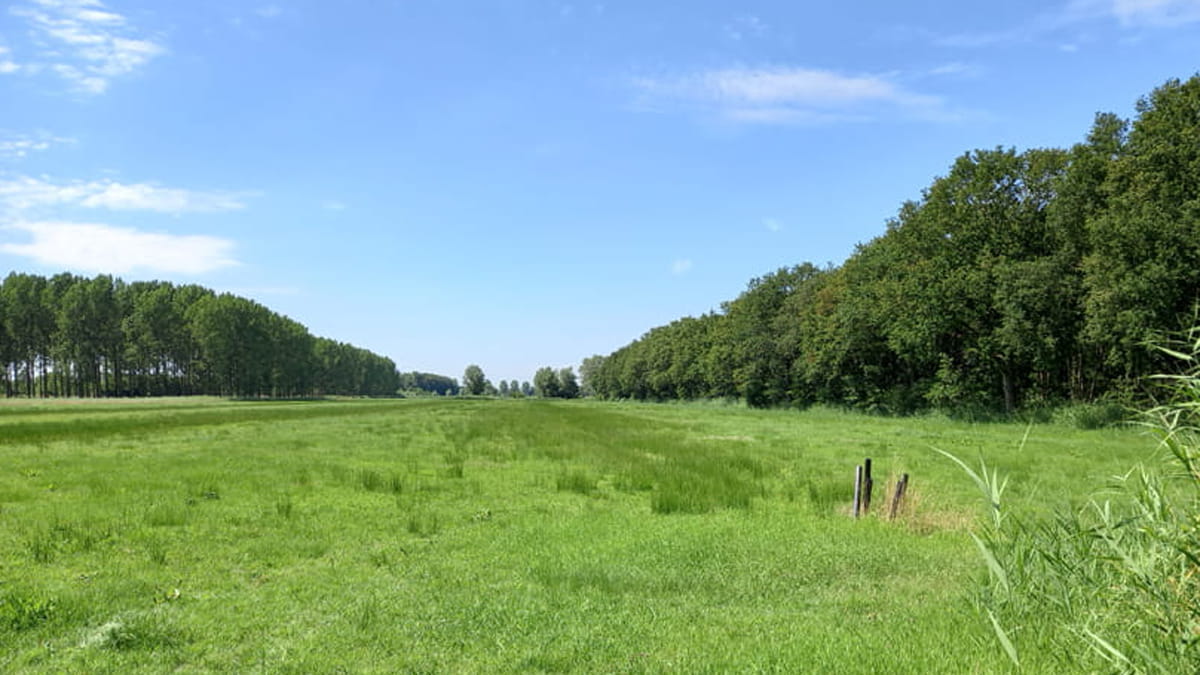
0, 273, 401, 398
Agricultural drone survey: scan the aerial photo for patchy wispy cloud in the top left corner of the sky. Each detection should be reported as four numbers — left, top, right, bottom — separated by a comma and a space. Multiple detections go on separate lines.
9, 0, 166, 94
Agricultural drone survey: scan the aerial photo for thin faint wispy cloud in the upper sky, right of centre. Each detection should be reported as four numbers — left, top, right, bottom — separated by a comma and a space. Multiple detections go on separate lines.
634, 66, 958, 124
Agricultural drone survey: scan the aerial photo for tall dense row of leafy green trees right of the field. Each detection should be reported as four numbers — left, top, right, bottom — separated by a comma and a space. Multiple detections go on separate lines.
581, 77, 1200, 412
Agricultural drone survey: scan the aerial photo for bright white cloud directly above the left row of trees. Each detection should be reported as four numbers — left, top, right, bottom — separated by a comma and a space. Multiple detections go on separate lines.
0, 222, 238, 274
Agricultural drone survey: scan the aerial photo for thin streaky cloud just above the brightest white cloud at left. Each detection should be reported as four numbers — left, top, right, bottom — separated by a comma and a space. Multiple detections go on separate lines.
0, 177, 250, 214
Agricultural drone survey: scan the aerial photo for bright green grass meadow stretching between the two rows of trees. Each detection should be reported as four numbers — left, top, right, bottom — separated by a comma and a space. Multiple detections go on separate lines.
0, 399, 1154, 673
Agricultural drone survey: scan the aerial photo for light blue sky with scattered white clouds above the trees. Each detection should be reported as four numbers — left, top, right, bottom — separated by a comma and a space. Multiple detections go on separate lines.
0, 0, 1200, 380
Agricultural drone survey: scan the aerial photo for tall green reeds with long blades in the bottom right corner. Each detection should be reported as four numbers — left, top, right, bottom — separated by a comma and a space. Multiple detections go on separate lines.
952, 329, 1200, 673
